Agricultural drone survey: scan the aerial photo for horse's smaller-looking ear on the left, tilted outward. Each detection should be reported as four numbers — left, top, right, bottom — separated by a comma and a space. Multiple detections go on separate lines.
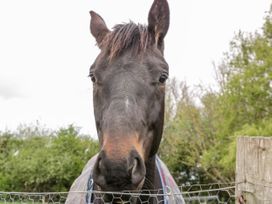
90, 11, 110, 48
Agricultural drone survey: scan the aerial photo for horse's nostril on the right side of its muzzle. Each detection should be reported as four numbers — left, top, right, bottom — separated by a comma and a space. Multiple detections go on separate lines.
131, 157, 146, 186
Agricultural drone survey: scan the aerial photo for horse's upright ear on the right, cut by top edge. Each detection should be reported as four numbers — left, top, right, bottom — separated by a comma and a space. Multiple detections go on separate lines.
148, 0, 170, 51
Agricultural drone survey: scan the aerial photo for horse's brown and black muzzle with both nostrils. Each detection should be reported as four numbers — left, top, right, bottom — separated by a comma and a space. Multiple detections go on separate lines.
93, 135, 146, 191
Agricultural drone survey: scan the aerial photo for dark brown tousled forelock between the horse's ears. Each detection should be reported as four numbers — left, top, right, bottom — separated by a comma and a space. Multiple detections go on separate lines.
99, 21, 149, 60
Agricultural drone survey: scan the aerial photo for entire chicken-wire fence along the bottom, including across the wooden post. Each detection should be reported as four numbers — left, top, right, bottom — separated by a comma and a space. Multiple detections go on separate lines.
3, 181, 272, 204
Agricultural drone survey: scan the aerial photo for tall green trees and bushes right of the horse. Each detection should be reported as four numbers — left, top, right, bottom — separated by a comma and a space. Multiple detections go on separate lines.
160, 6, 272, 184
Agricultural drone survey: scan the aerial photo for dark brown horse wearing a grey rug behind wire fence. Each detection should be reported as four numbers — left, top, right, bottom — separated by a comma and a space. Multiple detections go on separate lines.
66, 0, 184, 203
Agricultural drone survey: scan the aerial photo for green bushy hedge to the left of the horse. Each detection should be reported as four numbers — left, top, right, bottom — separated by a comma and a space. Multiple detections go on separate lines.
0, 126, 98, 191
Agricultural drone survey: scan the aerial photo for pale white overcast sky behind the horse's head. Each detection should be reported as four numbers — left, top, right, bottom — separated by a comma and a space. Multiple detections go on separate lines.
0, 0, 272, 135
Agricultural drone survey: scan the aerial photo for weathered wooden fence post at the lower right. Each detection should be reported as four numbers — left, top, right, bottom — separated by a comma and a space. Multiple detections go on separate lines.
235, 137, 272, 204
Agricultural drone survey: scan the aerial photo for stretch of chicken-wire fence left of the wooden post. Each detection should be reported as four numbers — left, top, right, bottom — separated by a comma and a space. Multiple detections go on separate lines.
0, 183, 236, 204
